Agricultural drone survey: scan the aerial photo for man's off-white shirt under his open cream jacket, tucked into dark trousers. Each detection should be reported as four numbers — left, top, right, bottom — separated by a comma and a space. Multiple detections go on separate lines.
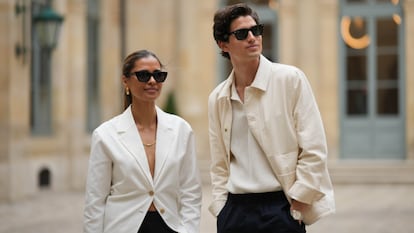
227, 85, 282, 194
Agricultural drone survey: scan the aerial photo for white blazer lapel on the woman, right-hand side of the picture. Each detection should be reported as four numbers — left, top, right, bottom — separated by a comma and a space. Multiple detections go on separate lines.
154, 107, 175, 182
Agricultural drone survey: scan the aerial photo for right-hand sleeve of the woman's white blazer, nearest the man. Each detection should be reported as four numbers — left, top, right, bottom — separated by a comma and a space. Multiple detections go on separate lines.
179, 131, 202, 233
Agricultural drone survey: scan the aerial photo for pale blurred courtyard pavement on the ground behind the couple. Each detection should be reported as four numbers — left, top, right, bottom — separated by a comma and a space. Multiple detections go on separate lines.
0, 185, 414, 233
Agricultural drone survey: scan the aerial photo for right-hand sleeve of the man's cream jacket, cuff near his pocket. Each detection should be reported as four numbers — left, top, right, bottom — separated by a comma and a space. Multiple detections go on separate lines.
289, 68, 329, 204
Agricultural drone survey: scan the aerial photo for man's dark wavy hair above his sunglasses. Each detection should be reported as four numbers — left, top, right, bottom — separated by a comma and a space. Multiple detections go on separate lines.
213, 3, 260, 59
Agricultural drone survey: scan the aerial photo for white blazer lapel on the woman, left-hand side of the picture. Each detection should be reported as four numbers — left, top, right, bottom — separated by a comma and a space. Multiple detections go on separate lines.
117, 106, 154, 183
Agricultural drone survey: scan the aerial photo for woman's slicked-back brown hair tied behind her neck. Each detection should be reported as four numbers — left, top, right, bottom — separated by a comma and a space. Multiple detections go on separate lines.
122, 49, 164, 109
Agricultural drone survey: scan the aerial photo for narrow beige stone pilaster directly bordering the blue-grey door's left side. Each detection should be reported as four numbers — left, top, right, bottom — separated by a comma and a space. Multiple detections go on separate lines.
314, 0, 340, 160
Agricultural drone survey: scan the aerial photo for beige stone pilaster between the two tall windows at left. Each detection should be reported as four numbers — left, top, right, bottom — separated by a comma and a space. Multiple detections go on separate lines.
57, 0, 89, 190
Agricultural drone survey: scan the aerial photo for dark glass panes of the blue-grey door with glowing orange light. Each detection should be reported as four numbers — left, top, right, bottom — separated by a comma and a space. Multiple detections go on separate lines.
340, 0, 401, 116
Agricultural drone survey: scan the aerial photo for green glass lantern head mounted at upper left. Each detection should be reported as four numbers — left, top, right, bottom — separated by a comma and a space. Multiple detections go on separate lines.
33, 5, 63, 51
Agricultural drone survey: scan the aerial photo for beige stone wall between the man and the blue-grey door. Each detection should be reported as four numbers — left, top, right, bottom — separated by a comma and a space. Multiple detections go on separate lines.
279, 0, 339, 160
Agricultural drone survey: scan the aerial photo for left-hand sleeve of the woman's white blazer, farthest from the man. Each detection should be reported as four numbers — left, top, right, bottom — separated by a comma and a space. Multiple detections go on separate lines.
83, 130, 112, 233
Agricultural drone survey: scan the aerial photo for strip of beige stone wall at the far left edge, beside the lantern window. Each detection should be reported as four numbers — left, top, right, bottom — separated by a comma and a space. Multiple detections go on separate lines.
0, 1, 30, 200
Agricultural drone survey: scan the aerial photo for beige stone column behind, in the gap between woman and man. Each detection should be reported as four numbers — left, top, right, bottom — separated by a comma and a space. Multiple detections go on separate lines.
175, 0, 217, 182
